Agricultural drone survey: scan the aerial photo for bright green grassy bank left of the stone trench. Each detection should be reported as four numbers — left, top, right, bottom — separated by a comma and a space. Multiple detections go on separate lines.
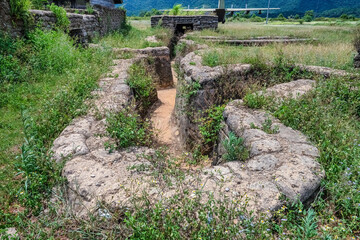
0, 30, 112, 221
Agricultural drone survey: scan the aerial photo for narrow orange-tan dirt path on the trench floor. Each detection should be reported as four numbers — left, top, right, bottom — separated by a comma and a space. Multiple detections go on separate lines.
151, 63, 180, 153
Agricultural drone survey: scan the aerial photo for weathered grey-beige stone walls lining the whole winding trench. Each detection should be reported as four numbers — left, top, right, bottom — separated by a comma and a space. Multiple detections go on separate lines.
52, 35, 360, 216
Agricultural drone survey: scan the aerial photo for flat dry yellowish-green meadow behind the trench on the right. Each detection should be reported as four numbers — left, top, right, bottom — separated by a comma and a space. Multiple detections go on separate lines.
189, 23, 356, 72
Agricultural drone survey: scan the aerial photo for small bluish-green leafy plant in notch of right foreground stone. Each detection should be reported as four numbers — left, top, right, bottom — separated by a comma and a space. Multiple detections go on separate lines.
222, 132, 249, 161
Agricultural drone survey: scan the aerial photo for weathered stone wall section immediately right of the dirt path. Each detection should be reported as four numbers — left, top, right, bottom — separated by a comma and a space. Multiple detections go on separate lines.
175, 50, 251, 147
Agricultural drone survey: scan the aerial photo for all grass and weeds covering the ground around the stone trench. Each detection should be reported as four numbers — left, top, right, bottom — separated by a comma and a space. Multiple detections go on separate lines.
0, 20, 360, 240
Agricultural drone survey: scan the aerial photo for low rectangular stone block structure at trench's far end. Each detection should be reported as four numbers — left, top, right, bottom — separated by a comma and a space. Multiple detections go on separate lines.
151, 15, 218, 33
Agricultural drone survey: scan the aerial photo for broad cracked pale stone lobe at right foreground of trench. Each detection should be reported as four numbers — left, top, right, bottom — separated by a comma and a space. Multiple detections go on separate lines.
214, 100, 324, 210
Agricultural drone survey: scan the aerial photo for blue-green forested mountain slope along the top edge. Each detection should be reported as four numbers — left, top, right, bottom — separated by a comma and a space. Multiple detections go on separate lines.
117, 0, 360, 15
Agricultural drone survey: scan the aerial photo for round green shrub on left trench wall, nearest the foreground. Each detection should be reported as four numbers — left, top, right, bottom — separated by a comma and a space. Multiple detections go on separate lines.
106, 107, 153, 149
